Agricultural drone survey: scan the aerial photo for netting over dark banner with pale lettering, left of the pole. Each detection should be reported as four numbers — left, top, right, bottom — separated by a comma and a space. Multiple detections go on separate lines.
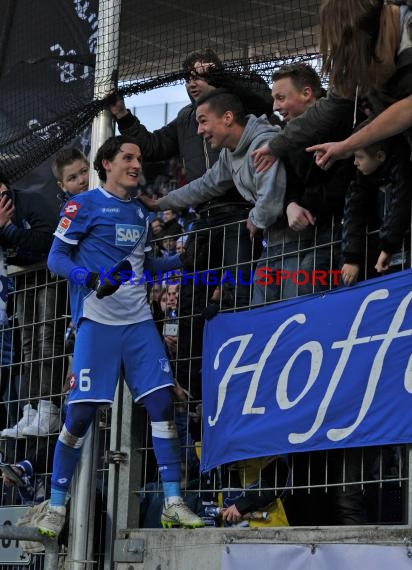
0, 0, 97, 182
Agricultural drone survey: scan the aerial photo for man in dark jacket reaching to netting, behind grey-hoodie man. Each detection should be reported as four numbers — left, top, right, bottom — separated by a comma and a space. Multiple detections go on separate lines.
110, 50, 272, 398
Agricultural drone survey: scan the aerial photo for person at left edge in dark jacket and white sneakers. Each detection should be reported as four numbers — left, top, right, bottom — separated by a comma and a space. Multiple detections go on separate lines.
0, 175, 66, 438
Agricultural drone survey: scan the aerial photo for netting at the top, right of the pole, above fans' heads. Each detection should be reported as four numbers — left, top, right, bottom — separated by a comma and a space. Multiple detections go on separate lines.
119, 0, 320, 81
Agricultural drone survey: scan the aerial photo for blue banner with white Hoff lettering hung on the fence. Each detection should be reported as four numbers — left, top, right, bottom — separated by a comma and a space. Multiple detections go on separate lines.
201, 270, 412, 471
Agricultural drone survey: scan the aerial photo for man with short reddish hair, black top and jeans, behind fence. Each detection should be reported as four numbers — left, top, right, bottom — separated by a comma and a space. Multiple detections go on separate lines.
253, 63, 354, 304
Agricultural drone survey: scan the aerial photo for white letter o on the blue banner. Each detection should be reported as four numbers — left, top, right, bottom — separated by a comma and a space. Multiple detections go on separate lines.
276, 341, 323, 410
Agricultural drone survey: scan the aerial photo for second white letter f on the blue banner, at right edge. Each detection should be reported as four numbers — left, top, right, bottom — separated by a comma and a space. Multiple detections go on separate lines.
327, 293, 412, 441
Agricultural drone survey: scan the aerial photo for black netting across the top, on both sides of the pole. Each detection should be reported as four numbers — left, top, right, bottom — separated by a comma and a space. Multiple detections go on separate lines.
0, 0, 320, 181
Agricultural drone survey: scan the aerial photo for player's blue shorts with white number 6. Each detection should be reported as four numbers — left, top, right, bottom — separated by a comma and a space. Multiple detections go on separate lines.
68, 319, 174, 404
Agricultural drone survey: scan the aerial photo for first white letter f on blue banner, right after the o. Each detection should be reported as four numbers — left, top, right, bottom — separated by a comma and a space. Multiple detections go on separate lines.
289, 289, 389, 443
